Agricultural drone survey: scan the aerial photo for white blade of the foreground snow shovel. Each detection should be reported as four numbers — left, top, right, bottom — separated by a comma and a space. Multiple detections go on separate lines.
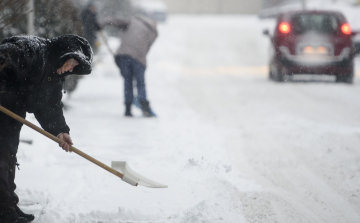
111, 161, 167, 188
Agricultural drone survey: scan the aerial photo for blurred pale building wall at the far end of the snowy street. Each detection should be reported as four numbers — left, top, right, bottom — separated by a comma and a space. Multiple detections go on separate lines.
163, 0, 261, 14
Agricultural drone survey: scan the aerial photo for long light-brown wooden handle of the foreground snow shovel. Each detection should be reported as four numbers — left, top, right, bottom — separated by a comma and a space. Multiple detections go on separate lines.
0, 105, 124, 178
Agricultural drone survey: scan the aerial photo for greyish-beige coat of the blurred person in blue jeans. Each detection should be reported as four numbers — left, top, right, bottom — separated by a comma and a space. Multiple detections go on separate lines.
100, 15, 158, 66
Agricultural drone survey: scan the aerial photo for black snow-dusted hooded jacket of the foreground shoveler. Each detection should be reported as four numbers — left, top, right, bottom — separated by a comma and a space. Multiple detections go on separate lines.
0, 35, 93, 135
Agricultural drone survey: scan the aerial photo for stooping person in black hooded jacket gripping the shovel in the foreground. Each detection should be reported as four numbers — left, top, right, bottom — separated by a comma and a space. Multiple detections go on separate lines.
0, 35, 93, 223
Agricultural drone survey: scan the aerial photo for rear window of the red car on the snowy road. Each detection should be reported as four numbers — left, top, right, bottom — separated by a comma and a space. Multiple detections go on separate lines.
291, 14, 339, 34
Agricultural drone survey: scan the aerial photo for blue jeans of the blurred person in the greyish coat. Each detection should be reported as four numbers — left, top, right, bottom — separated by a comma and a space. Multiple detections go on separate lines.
115, 55, 146, 104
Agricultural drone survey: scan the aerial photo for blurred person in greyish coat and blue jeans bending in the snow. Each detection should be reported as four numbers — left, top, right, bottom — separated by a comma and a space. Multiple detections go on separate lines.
100, 15, 158, 117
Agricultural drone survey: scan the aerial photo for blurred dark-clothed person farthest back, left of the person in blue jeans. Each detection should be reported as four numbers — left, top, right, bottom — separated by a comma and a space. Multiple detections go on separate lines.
81, 1, 100, 50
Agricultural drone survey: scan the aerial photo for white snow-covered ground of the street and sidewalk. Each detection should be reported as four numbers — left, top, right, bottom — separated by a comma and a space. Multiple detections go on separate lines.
16, 15, 360, 223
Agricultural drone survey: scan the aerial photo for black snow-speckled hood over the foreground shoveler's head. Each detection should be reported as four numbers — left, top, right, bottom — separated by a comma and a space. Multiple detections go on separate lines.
49, 35, 93, 75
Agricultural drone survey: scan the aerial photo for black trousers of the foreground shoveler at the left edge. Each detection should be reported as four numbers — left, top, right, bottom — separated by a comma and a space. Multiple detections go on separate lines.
0, 92, 26, 216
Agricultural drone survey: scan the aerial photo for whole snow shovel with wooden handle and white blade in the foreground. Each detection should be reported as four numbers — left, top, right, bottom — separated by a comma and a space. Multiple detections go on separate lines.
0, 105, 167, 188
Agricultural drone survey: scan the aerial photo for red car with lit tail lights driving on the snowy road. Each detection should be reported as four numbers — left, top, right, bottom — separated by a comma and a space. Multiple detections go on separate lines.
264, 11, 356, 83
